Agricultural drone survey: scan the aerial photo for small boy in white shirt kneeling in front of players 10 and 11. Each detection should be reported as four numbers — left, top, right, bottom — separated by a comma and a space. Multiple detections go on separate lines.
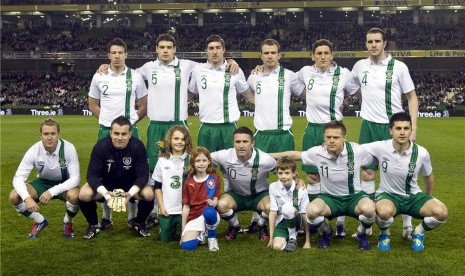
268, 156, 310, 252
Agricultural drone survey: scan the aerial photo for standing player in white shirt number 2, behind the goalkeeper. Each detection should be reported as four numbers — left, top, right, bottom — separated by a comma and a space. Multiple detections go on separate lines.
88, 38, 147, 226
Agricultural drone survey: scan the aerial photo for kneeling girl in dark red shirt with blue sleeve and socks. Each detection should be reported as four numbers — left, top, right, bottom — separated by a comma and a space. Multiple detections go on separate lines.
181, 147, 221, 251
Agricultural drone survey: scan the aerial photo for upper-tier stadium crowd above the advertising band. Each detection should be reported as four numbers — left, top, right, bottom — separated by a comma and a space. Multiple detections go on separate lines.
1, 18, 465, 52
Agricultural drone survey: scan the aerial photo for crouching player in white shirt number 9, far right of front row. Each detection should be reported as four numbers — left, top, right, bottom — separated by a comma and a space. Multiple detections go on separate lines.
363, 112, 448, 251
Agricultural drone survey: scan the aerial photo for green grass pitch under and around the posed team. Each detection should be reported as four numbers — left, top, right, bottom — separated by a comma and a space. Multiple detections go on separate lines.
0, 116, 465, 275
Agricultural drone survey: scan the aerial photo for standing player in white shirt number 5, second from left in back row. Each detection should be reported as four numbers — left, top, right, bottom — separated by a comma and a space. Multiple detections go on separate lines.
136, 34, 197, 171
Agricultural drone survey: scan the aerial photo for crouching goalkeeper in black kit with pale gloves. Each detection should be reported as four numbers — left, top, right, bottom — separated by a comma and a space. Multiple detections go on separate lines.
79, 116, 154, 239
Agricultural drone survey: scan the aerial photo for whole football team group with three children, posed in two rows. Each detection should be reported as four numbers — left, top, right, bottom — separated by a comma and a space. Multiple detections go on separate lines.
9, 28, 448, 252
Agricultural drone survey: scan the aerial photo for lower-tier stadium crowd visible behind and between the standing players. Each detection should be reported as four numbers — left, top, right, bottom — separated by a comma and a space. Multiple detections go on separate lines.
0, 68, 465, 110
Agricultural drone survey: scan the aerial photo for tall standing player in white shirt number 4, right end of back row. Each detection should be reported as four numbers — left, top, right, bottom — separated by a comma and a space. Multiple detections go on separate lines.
346, 28, 418, 238
